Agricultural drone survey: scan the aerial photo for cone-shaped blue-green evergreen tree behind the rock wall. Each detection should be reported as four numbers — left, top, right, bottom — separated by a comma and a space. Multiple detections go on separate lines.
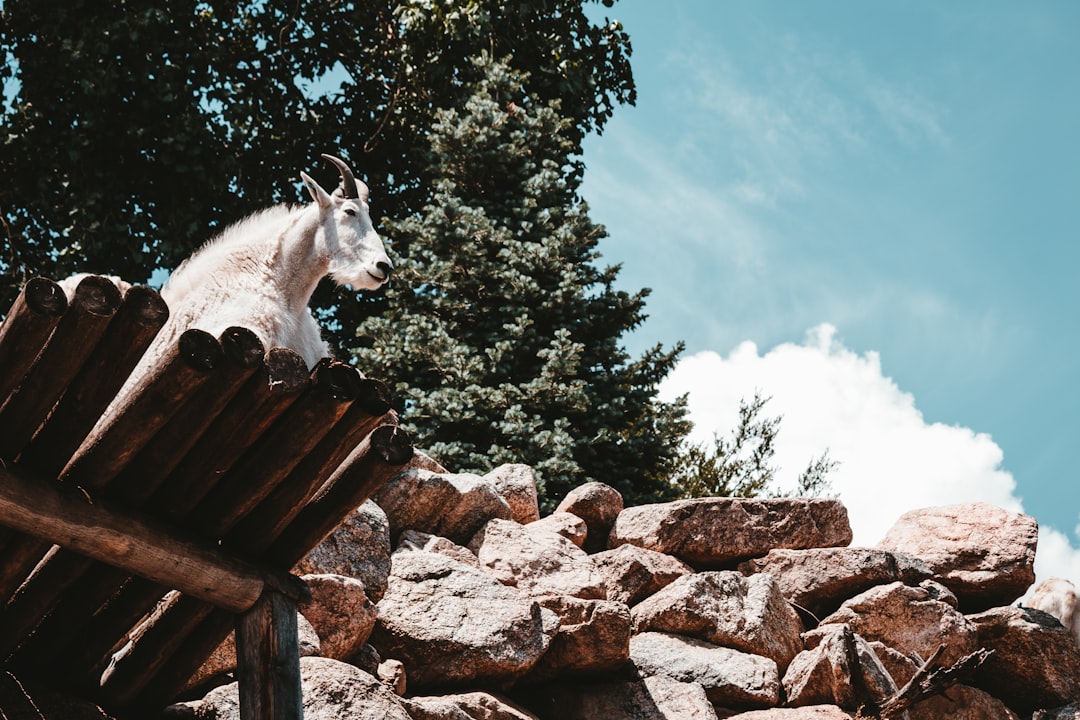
354, 57, 689, 510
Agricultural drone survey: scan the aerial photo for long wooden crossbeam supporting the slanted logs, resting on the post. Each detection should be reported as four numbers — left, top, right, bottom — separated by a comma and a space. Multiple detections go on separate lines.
0, 468, 274, 612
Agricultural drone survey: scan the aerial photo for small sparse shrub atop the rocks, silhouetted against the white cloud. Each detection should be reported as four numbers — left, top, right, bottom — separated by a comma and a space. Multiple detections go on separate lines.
671, 392, 838, 498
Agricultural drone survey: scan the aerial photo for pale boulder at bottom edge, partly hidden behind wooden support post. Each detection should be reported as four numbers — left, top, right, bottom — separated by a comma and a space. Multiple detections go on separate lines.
165, 657, 411, 720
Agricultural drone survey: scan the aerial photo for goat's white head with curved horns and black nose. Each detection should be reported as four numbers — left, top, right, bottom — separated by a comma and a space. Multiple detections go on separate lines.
300, 154, 394, 290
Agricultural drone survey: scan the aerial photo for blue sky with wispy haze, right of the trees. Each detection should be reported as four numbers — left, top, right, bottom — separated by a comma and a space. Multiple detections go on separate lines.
582, 0, 1080, 574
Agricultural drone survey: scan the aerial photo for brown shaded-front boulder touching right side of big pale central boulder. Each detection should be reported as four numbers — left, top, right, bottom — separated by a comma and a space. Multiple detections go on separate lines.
523, 595, 630, 682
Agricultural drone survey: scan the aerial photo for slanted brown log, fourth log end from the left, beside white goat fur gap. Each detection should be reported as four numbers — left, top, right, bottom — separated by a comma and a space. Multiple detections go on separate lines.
60, 329, 221, 489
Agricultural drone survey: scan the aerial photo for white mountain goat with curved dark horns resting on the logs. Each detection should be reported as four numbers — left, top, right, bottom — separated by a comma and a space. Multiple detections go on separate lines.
151, 154, 393, 367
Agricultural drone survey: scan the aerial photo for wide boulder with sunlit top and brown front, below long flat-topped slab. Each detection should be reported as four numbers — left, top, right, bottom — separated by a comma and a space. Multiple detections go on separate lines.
631, 570, 802, 670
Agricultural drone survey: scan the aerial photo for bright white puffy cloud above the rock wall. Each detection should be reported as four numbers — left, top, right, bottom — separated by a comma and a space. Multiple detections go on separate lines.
661, 325, 1080, 582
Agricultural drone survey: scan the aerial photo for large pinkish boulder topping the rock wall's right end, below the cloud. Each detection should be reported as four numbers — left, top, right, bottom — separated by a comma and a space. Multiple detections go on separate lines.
878, 503, 1039, 612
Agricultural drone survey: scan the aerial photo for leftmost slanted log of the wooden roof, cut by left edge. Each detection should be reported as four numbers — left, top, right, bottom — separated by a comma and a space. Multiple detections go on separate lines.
0, 277, 67, 405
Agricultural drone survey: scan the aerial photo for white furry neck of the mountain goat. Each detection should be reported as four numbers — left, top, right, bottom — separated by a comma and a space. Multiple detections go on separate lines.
273, 205, 329, 314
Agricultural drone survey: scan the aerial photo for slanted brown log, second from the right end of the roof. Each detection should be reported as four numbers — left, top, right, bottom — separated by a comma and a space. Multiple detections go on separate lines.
226, 378, 396, 553
